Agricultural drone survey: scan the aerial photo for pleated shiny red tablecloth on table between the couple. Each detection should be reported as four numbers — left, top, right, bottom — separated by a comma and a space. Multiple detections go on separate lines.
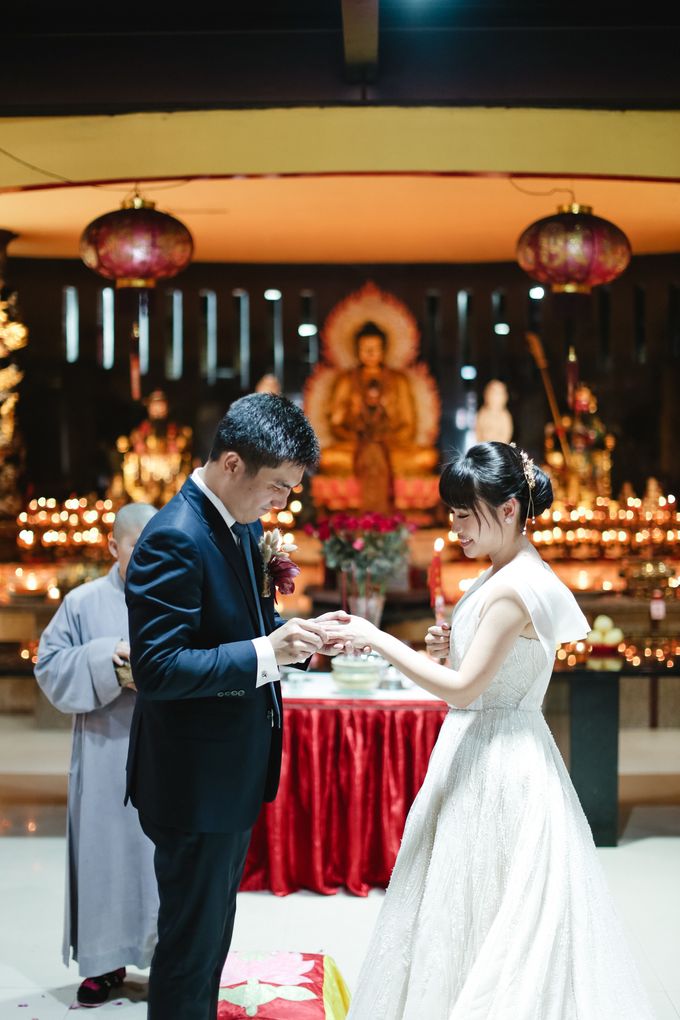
241, 697, 447, 896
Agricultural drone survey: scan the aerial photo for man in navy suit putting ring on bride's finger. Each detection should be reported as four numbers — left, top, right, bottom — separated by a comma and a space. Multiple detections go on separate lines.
124, 394, 336, 1020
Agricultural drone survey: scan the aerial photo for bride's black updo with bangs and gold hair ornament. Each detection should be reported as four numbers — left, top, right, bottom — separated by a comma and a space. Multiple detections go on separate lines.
439, 443, 553, 525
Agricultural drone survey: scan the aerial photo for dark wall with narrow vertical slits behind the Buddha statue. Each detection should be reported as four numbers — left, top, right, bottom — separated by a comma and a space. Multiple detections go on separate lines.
9, 255, 680, 495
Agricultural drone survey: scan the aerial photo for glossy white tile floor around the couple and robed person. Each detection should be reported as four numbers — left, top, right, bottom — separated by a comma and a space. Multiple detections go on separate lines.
0, 717, 680, 1020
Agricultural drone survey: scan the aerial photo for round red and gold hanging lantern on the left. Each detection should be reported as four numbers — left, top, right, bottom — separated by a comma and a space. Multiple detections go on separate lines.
81, 195, 194, 288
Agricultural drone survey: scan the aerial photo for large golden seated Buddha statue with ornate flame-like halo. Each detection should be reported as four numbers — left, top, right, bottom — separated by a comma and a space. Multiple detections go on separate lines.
305, 284, 439, 513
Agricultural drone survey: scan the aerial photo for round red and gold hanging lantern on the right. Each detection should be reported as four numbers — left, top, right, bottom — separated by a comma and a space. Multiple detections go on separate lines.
517, 202, 631, 294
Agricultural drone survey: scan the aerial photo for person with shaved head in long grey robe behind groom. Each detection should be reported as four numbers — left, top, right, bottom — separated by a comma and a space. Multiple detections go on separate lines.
35, 503, 158, 1006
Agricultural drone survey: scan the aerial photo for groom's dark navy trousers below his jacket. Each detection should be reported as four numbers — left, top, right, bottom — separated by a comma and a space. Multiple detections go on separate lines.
140, 816, 251, 1020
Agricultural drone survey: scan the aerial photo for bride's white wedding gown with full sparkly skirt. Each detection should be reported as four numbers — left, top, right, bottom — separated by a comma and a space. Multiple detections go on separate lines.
348, 552, 652, 1020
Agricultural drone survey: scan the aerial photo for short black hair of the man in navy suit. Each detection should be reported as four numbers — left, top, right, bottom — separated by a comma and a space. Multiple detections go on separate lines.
210, 393, 319, 474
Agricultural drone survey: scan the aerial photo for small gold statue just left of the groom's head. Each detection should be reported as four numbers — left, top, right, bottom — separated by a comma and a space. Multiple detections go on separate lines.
109, 390, 192, 507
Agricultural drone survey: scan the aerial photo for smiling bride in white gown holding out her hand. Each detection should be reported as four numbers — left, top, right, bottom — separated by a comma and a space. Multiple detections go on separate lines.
343, 443, 652, 1020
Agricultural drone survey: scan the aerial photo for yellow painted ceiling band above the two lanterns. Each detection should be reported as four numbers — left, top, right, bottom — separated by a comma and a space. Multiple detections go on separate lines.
0, 106, 680, 190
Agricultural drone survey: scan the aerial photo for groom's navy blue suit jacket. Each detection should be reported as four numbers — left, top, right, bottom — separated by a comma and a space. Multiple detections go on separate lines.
125, 478, 283, 832
